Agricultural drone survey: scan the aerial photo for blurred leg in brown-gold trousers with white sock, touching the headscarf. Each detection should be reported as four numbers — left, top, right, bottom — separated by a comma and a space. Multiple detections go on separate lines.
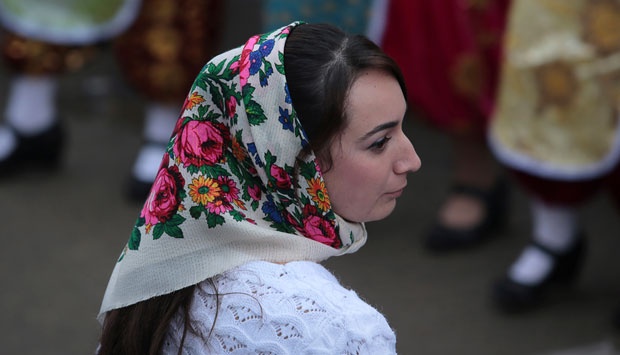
115, 0, 223, 201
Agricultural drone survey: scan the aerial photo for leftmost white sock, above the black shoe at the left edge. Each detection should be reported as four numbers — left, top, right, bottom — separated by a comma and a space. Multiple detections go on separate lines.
5, 75, 57, 136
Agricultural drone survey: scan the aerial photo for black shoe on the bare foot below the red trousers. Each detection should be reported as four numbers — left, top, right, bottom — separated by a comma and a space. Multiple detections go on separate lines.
424, 178, 509, 252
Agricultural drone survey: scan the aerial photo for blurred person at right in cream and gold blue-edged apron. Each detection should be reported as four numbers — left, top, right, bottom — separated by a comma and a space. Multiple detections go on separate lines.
489, 0, 620, 320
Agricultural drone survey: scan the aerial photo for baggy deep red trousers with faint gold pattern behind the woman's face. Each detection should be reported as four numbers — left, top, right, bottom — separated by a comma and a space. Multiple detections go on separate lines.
382, 0, 509, 131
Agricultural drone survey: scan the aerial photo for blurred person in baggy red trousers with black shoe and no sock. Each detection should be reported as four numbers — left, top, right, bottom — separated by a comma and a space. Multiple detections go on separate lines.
369, 0, 510, 252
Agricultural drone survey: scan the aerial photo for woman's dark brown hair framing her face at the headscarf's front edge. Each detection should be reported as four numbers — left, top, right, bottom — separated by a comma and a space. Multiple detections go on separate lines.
284, 24, 407, 172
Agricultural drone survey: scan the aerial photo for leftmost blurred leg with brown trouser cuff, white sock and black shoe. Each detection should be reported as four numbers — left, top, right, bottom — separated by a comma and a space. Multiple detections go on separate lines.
0, 32, 92, 174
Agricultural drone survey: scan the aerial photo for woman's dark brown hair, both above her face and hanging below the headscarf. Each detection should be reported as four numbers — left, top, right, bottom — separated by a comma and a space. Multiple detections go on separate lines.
99, 24, 407, 355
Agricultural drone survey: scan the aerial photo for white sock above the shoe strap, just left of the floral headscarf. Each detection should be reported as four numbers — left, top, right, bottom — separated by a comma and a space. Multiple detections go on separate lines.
144, 103, 181, 144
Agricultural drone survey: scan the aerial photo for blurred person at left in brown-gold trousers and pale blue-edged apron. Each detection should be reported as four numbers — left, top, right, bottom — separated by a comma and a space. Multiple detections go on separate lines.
0, 0, 221, 200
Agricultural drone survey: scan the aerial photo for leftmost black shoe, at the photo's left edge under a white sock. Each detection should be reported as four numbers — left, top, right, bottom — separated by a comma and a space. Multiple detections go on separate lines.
0, 122, 64, 176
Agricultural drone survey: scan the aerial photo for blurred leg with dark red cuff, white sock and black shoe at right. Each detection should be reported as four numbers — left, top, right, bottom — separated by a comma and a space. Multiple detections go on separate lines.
493, 172, 602, 311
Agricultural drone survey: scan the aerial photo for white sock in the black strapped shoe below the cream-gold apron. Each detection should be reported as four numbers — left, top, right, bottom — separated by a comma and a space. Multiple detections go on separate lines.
508, 200, 578, 285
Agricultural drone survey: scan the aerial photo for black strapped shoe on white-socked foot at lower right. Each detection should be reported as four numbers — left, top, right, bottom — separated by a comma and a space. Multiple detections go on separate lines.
492, 234, 586, 313
